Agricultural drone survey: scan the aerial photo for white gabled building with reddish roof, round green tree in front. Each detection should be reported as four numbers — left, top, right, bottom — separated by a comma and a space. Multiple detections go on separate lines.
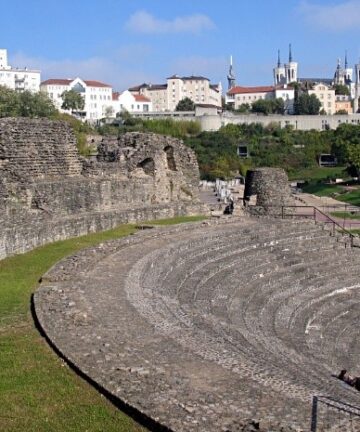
40, 78, 114, 121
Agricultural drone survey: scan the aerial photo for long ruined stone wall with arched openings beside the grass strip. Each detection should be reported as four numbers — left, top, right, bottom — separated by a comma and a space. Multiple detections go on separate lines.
0, 119, 205, 258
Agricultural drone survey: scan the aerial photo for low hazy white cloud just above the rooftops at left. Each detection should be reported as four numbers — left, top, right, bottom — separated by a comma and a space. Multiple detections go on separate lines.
9, 51, 159, 90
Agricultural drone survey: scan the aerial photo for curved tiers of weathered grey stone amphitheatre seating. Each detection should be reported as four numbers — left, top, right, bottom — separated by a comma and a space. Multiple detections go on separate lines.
35, 219, 360, 432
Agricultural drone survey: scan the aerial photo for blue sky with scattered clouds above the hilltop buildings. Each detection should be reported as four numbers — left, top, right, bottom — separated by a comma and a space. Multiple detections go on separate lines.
0, 0, 360, 91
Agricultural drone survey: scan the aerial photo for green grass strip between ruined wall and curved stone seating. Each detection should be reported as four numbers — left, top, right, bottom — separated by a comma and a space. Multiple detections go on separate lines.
0, 217, 205, 432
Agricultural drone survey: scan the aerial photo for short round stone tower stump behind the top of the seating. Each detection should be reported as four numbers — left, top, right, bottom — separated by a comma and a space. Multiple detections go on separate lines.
244, 168, 294, 214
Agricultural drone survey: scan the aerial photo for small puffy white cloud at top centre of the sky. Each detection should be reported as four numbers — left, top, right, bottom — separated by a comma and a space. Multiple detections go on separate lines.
125, 11, 215, 34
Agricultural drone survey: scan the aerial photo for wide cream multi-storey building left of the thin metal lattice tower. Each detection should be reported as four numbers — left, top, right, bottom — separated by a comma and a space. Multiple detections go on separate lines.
129, 75, 222, 112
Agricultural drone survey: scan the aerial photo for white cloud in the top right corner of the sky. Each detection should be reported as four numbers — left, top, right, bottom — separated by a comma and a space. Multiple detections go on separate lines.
299, 0, 360, 31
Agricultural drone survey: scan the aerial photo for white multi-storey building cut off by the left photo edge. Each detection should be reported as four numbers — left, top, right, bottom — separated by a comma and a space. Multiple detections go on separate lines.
0, 49, 40, 92
